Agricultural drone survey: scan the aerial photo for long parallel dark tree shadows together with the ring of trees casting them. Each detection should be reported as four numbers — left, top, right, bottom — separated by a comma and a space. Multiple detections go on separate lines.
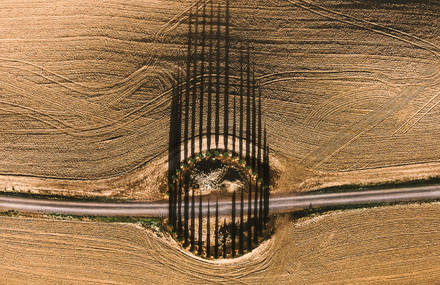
168, 0, 270, 258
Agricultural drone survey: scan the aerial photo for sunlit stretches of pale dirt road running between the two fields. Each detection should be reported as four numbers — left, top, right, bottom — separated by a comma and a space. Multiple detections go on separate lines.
0, 185, 440, 217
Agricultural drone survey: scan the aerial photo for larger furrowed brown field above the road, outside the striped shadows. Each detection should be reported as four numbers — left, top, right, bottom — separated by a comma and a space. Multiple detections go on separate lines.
0, 0, 440, 197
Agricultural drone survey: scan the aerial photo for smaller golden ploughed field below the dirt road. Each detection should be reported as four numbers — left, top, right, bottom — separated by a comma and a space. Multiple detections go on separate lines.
0, 203, 440, 284
